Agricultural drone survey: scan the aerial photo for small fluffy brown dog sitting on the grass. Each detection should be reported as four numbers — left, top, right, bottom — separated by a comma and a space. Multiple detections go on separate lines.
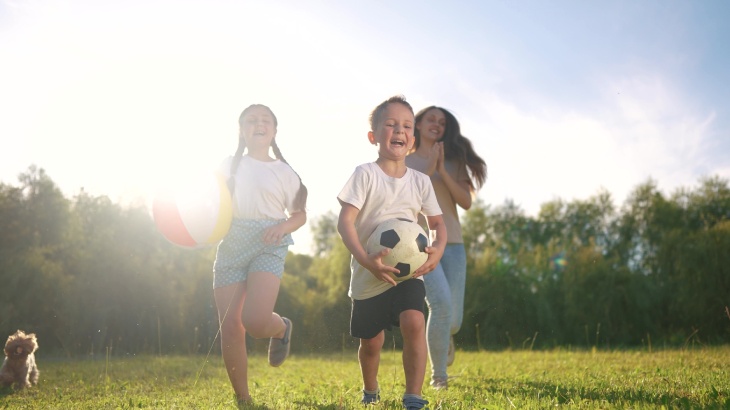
0, 330, 38, 389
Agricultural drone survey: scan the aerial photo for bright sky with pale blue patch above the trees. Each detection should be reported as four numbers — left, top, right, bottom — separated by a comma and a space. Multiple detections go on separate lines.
0, 0, 730, 253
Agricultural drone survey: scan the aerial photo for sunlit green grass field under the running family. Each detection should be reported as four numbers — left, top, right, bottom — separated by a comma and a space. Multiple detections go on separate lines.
0, 346, 730, 409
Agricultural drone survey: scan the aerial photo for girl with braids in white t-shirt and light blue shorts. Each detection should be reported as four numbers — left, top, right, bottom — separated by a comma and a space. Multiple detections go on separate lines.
213, 104, 307, 404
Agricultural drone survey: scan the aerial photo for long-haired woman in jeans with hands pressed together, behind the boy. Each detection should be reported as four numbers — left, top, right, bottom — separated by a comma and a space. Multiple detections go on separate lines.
406, 106, 487, 389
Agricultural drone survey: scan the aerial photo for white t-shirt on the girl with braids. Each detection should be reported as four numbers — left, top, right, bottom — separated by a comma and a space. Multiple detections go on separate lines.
220, 155, 302, 220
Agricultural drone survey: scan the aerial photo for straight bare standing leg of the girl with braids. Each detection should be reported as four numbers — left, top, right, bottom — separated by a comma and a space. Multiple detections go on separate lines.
213, 282, 251, 401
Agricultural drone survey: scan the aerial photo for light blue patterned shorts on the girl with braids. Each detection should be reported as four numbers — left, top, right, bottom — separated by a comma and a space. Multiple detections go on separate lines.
213, 219, 294, 289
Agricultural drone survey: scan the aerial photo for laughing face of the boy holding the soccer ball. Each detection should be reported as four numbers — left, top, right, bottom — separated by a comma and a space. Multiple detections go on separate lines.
368, 103, 415, 161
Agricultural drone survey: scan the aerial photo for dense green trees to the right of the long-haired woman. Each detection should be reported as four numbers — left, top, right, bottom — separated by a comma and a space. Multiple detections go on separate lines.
457, 178, 730, 348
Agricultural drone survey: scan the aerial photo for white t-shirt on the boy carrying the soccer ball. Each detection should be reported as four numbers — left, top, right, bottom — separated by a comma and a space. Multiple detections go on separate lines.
337, 162, 441, 300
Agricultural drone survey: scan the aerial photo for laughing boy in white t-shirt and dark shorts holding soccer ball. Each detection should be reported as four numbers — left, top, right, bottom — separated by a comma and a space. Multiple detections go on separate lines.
337, 96, 446, 410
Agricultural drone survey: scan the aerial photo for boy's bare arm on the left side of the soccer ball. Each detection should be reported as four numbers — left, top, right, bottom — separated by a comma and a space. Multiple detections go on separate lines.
337, 203, 398, 286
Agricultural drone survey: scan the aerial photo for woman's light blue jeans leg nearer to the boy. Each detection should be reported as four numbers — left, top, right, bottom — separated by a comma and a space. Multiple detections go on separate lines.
423, 262, 452, 381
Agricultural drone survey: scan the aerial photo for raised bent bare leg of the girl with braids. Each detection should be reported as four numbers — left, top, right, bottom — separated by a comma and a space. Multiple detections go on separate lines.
243, 272, 286, 339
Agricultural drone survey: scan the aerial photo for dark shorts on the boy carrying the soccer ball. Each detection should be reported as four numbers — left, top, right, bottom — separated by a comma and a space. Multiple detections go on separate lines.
350, 279, 426, 339
